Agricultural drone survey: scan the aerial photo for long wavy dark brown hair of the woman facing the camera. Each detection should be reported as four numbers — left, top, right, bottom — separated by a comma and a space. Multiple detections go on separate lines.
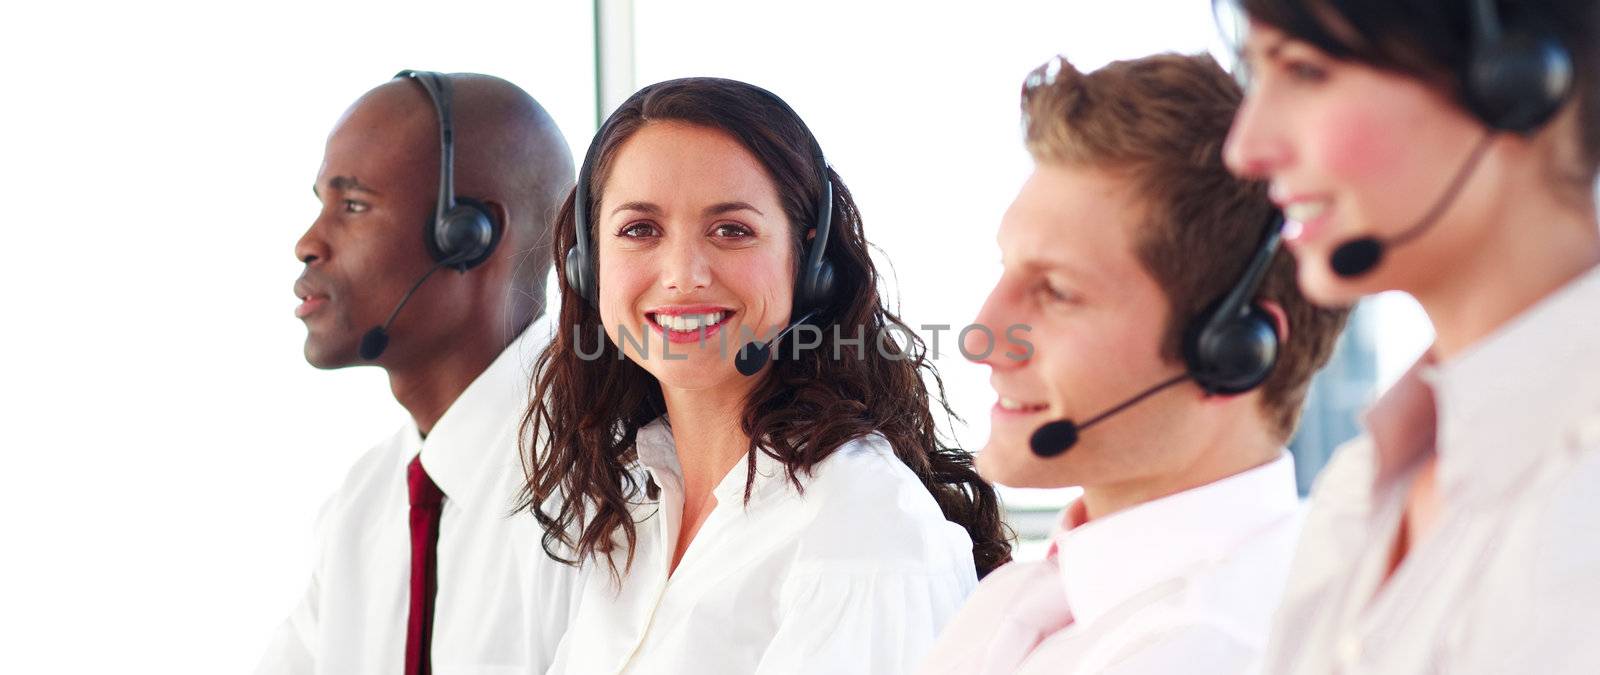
523, 78, 1011, 576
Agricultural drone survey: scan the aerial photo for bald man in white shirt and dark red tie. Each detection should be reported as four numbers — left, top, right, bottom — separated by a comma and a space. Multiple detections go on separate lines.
258, 74, 576, 675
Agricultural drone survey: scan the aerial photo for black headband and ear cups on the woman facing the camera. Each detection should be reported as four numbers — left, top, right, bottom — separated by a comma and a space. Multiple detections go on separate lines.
566, 78, 834, 314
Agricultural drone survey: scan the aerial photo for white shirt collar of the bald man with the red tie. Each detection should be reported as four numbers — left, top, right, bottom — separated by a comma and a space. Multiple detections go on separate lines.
419, 317, 550, 507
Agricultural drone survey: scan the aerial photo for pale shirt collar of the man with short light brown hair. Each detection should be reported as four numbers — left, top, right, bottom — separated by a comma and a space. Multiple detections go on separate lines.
1050, 453, 1299, 624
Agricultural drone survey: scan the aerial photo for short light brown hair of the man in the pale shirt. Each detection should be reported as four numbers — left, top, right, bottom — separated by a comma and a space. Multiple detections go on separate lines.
1022, 54, 1349, 440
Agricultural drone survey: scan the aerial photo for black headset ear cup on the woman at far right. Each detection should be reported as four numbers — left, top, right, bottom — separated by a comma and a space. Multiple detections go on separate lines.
1461, 0, 1573, 134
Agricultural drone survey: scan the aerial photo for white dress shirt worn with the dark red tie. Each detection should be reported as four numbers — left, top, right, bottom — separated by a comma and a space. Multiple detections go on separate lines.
246, 322, 579, 675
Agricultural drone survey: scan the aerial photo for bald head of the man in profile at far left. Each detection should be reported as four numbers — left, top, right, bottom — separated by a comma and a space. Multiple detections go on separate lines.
294, 75, 573, 377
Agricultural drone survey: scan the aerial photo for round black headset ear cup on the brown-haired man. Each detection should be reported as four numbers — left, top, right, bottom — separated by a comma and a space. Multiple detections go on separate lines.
1184, 304, 1278, 395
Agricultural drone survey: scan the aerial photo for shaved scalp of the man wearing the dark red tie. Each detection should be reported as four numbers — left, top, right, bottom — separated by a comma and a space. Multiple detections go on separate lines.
330, 74, 573, 310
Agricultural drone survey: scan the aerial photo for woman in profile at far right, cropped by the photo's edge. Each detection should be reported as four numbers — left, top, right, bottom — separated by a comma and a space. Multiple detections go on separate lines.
1227, 0, 1600, 673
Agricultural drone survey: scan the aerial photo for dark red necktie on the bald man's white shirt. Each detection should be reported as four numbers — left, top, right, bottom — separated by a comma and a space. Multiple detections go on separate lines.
405, 454, 445, 675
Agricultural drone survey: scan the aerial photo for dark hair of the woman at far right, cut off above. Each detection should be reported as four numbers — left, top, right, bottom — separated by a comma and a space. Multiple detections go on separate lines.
1213, 0, 1600, 187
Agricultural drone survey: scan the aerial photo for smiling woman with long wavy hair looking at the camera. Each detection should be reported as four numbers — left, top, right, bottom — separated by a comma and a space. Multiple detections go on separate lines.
526, 78, 1010, 675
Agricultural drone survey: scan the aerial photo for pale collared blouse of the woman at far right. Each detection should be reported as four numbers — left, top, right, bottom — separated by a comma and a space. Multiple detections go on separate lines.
1267, 269, 1600, 675
